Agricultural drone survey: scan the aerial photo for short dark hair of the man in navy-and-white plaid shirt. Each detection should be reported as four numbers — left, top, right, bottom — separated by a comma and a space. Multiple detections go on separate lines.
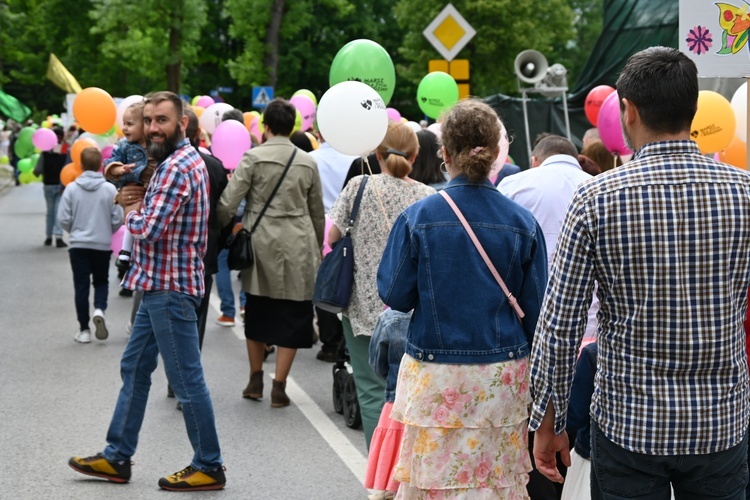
617, 47, 698, 134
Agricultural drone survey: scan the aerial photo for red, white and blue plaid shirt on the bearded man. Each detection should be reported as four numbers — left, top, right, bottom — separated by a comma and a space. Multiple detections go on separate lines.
122, 139, 209, 297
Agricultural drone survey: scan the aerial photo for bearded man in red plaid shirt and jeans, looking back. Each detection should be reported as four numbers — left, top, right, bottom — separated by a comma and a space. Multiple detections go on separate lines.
69, 92, 226, 491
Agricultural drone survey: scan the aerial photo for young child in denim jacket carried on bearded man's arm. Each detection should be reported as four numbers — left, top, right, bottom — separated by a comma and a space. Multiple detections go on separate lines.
104, 102, 154, 274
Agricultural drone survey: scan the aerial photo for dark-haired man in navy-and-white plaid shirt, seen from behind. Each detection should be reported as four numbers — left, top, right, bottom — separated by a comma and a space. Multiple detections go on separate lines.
530, 47, 750, 499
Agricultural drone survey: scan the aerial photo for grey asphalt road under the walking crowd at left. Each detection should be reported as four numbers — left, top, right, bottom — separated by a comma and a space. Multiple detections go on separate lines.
0, 184, 367, 500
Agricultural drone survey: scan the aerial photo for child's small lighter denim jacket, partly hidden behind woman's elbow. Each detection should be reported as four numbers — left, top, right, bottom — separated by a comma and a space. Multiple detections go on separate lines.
370, 309, 411, 403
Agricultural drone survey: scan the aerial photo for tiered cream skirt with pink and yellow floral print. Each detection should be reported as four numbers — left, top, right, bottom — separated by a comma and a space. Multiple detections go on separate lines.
391, 355, 531, 499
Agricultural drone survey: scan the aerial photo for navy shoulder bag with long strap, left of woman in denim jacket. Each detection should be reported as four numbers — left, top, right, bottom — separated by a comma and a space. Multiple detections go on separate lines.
313, 176, 369, 313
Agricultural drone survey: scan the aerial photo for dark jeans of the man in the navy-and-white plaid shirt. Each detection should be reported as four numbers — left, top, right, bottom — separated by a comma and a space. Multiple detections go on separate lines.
591, 420, 748, 500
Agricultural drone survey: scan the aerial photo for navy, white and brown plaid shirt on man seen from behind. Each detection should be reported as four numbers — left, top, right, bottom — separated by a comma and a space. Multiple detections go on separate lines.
530, 141, 750, 455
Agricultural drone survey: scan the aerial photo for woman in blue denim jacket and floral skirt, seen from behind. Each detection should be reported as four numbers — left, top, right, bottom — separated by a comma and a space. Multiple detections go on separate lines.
378, 100, 547, 498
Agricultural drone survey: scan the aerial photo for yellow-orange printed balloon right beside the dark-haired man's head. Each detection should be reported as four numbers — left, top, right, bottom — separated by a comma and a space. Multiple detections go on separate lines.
690, 90, 737, 154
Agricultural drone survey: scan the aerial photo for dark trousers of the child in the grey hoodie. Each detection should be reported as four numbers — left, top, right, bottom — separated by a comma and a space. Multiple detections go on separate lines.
68, 248, 112, 331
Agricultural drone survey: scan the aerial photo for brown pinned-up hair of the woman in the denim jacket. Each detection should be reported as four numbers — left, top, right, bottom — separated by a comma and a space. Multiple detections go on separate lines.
440, 99, 500, 182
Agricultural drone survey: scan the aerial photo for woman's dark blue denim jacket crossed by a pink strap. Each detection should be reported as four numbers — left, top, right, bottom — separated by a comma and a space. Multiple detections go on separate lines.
378, 176, 547, 364
